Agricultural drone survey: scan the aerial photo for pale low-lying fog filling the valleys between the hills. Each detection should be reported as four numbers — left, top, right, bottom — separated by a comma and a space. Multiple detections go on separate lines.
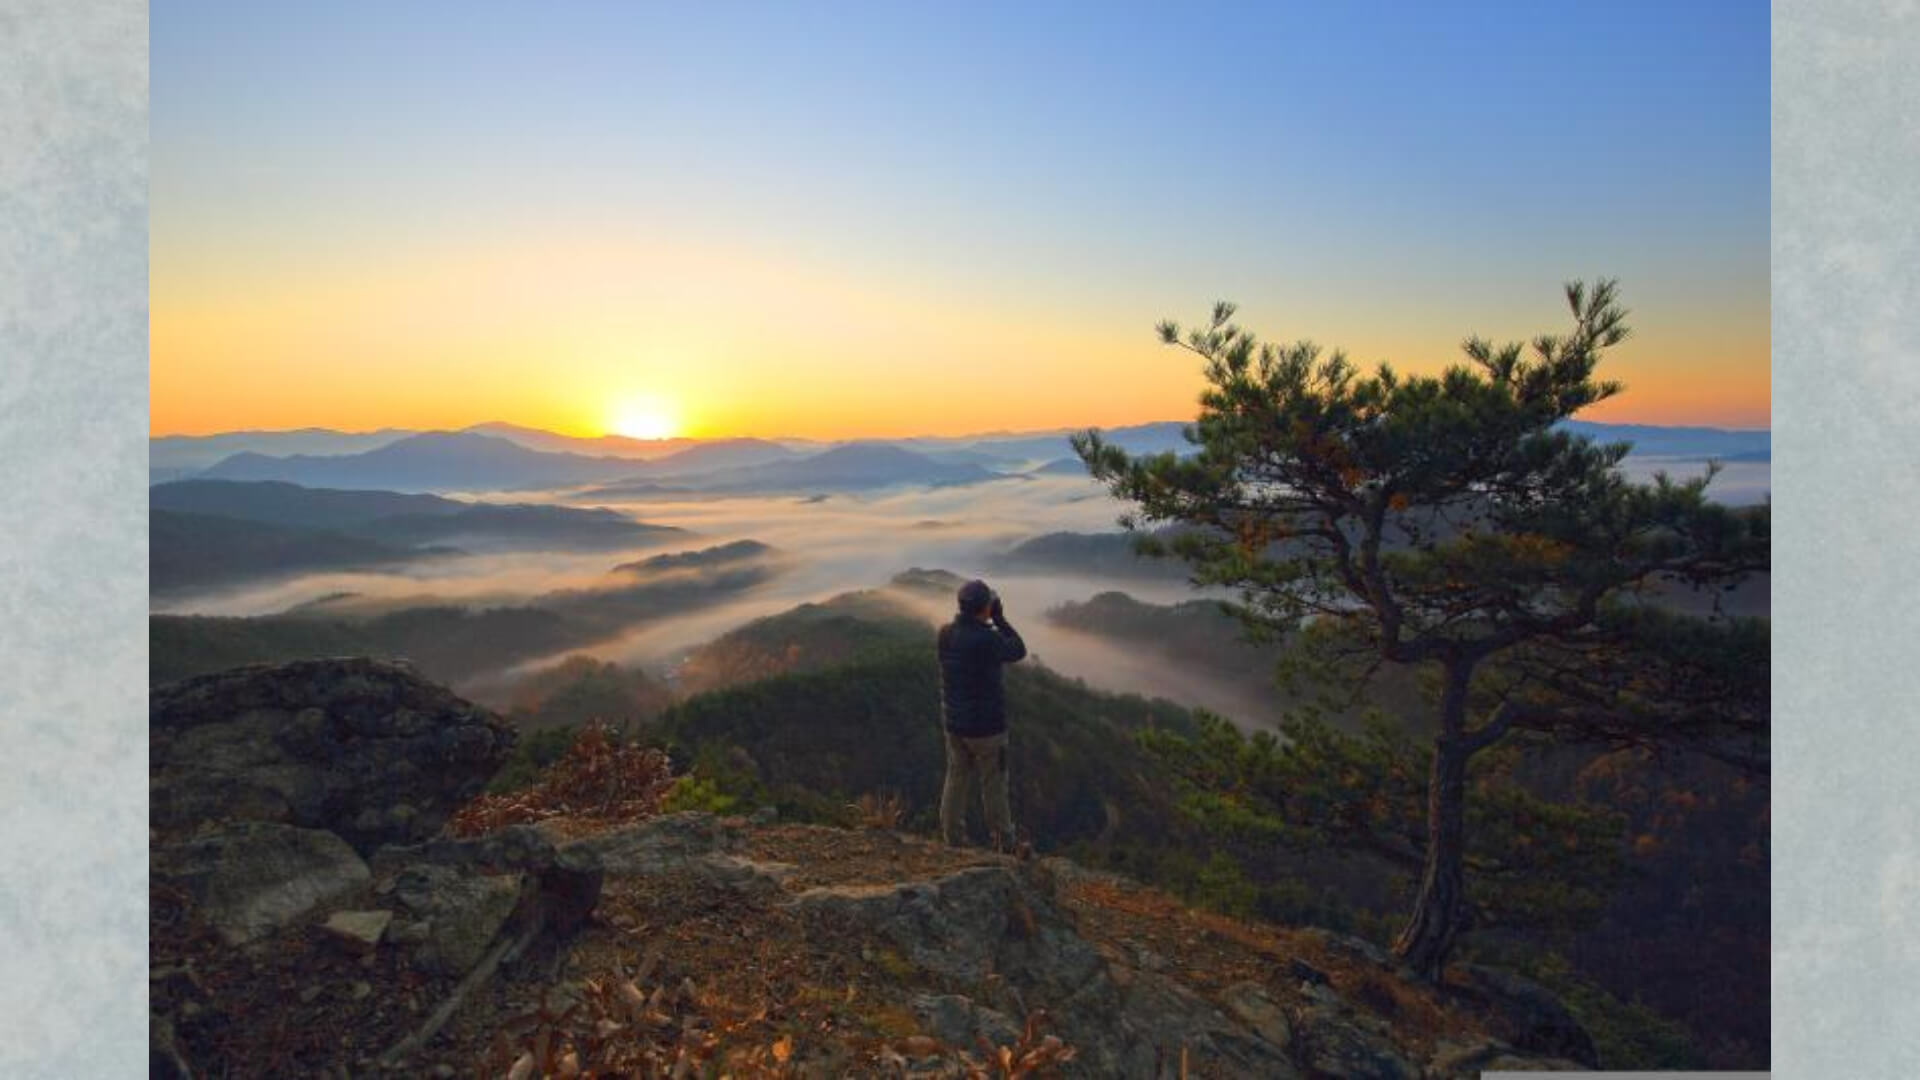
154, 461, 1766, 726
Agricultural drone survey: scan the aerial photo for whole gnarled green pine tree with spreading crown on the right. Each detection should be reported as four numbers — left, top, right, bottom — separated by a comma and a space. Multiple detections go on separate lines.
1073, 281, 1768, 978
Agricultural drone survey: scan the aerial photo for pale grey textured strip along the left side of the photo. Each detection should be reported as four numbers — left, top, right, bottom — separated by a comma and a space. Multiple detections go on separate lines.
0, 0, 146, 1078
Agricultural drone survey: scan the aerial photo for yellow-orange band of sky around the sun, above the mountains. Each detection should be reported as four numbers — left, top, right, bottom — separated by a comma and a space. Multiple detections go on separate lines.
150, 231, 1768, 438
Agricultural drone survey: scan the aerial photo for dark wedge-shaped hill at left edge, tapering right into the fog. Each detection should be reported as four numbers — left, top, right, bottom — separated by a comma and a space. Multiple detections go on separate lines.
148, 509, 451, 592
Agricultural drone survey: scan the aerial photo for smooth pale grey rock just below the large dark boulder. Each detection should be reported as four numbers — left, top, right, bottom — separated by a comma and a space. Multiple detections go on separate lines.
152, 821, 371, 944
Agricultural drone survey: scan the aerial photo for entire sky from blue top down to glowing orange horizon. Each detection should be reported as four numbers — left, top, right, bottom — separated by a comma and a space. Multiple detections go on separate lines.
150, 4, 1770, 438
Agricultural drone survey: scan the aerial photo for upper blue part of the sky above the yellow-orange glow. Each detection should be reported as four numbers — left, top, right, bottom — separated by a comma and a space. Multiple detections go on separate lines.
152, 0, 1768, 425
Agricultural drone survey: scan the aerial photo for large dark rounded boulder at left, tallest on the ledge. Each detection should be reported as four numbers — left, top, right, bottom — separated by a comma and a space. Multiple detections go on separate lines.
148, 659, 515, 855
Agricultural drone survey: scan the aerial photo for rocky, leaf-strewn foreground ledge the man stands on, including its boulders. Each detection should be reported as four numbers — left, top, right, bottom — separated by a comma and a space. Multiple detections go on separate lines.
152, 659, 1594, 1080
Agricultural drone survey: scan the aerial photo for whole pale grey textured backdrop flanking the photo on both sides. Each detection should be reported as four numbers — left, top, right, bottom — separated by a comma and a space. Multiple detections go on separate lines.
0, 0, 1920, 1078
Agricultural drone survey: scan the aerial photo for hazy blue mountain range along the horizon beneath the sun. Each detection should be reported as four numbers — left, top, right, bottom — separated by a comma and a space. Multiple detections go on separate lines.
150, 421, 1772, 490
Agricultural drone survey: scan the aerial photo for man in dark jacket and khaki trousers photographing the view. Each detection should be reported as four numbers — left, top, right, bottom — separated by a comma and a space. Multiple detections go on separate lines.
939, 580, 1027, 851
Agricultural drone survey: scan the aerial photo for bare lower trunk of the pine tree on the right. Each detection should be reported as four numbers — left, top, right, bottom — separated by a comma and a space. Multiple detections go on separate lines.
1394, 669, 1471, 982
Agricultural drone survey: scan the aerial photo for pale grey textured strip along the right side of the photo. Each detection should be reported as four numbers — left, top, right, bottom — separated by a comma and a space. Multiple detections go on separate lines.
1772, 0, 1920, 1076
